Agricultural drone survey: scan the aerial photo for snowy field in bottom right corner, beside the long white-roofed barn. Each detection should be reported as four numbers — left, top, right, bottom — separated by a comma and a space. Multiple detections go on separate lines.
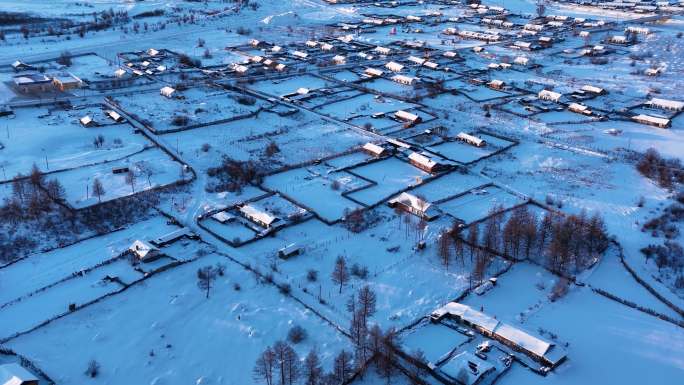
489, 282, 684, 385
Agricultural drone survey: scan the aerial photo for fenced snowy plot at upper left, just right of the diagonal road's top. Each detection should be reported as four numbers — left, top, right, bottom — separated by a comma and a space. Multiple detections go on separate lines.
115, 88, 264, 133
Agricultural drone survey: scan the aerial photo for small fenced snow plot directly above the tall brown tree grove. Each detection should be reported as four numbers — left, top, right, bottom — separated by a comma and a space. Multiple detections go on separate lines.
439, 186, 524, 223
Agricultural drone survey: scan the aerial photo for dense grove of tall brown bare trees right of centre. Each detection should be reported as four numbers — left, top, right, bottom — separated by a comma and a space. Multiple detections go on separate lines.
437, 205, 608, 282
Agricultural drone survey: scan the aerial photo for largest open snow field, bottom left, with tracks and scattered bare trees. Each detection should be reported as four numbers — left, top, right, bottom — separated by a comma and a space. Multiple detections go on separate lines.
10, 255, 350, 385
